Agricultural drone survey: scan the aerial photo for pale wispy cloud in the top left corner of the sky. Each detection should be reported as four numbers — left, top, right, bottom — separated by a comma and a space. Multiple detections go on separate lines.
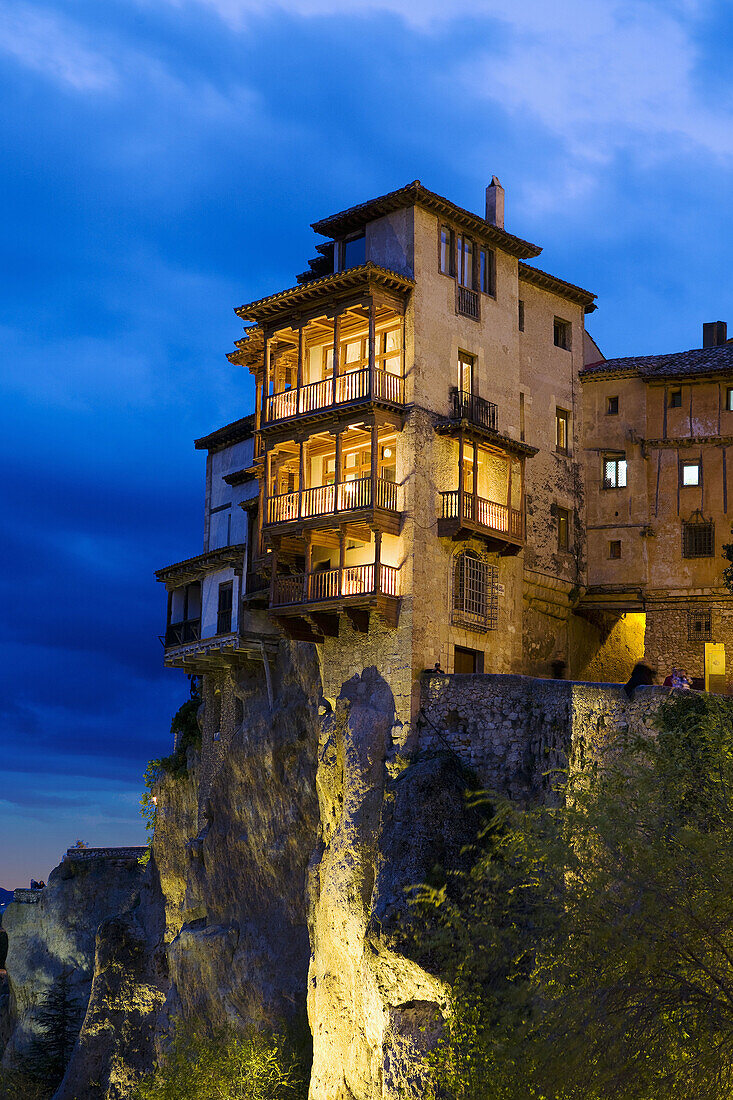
0, 2, 117, 91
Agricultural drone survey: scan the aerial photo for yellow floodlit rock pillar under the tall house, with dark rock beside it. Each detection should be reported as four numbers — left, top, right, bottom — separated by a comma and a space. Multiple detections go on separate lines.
308, 669, 477, 1100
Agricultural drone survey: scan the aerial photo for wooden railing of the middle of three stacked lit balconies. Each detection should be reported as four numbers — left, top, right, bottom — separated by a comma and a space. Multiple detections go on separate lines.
264, 477, 400, 534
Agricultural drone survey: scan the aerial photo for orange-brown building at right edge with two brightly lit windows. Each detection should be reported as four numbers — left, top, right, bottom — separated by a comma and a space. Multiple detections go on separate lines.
580, 321, 733, 691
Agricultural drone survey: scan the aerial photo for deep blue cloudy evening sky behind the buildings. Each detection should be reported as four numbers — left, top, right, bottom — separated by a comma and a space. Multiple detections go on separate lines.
0, 0, 733, 888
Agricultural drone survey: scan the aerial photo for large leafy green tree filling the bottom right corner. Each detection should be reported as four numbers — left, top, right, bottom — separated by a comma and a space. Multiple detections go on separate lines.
416, 693, 733, 1100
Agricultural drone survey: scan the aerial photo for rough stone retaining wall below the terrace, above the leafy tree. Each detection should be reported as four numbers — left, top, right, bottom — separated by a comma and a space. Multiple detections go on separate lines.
418, 673, 669, 801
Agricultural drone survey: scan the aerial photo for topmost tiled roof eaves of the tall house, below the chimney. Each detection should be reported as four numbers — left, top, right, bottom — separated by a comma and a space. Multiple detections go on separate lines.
311, 179, 543, 260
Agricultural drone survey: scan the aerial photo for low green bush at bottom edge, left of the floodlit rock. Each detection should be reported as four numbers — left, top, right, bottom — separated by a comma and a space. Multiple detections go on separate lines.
134, 1025, 308, 1100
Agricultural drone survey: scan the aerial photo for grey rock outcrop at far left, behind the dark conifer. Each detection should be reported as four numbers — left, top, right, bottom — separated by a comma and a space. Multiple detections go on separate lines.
2, 859, 143, 1066
